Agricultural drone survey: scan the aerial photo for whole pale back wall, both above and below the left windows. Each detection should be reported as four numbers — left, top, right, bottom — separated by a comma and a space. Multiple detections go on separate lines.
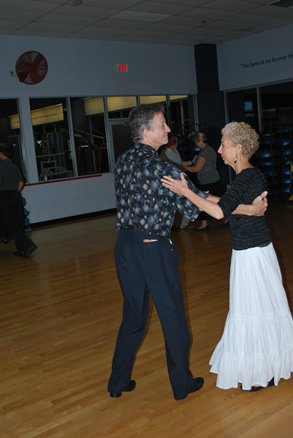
0, 36, 197, 224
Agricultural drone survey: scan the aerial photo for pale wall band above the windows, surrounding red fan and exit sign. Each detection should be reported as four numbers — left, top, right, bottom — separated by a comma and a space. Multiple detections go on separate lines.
0, 36, 197, 97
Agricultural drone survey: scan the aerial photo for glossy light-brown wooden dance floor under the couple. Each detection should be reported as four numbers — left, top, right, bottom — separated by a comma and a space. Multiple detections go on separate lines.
0, 203, 293, 438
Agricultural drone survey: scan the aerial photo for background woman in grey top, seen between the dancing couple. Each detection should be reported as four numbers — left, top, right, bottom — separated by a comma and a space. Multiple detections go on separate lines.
184, 132, 228, 231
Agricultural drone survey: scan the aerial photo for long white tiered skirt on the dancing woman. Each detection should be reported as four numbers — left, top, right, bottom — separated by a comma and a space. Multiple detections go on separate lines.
210, 244, 293, 390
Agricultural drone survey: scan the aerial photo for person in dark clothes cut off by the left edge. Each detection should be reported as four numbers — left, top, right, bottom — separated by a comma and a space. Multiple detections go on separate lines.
0, 143, 37, 257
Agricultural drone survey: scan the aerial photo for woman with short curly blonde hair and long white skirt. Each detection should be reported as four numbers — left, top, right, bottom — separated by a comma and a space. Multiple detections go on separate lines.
163, 122, 293, 392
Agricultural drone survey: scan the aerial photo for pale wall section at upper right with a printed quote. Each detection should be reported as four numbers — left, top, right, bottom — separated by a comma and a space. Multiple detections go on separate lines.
217, 25, 293, 90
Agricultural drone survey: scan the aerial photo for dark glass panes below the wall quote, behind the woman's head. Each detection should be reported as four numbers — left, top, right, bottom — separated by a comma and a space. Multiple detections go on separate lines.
226, 82, 293, 199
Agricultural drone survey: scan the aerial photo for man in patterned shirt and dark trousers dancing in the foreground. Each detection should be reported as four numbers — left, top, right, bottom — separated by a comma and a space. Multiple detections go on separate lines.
108, 104, 264, 400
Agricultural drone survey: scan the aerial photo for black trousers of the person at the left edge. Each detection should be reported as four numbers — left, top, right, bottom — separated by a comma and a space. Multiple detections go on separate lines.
0, 190, 33, 251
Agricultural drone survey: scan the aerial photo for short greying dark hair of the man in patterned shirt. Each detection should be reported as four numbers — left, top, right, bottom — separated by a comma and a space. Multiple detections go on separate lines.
129, 103, 165, 143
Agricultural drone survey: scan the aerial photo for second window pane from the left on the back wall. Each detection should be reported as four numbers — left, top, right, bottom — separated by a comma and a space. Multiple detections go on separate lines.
30, 98, 74, 181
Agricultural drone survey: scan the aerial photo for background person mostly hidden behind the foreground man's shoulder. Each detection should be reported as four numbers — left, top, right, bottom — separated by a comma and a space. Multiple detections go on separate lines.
160, 132, 194, 231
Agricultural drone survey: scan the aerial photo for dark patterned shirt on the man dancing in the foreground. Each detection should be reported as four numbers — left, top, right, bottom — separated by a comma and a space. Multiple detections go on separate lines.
115, 143, 208, 236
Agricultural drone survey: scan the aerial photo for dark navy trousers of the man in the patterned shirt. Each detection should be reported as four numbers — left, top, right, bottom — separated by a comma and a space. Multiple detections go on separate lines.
108, 229, 193, 400
